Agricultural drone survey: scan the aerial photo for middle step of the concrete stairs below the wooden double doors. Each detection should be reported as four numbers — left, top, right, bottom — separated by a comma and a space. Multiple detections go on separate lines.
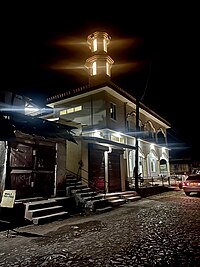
25, 206, 63, 221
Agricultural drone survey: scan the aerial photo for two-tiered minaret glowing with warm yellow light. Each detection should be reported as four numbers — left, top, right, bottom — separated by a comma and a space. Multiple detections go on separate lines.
85, 32, 114, 86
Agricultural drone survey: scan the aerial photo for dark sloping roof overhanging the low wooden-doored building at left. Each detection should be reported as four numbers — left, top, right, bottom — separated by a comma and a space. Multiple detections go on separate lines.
0, 111, 77, 143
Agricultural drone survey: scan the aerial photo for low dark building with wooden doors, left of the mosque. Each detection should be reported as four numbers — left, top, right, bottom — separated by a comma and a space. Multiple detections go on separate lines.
0, 91, 76, 199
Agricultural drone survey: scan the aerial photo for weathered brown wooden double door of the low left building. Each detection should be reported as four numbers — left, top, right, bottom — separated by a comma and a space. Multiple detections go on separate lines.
6, 143, 56, 199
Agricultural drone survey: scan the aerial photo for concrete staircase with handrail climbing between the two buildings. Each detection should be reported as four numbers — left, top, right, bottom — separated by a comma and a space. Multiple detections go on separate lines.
66, 175, 112, 216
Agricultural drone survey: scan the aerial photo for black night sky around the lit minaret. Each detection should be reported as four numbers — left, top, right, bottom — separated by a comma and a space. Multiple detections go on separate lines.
0, 1, 200, 159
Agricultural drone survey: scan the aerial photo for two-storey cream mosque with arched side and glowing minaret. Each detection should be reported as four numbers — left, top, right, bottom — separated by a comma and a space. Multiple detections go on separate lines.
43, 32, 170, 193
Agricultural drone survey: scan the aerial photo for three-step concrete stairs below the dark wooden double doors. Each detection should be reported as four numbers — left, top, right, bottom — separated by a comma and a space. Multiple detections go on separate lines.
24, 199, 69, 224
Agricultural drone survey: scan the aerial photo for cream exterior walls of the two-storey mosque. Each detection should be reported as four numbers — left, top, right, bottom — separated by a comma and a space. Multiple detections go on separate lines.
47, 86, 169, 190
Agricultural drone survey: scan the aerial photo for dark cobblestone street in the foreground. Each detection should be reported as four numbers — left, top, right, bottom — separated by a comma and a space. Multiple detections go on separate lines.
0, 191, 200, 267
